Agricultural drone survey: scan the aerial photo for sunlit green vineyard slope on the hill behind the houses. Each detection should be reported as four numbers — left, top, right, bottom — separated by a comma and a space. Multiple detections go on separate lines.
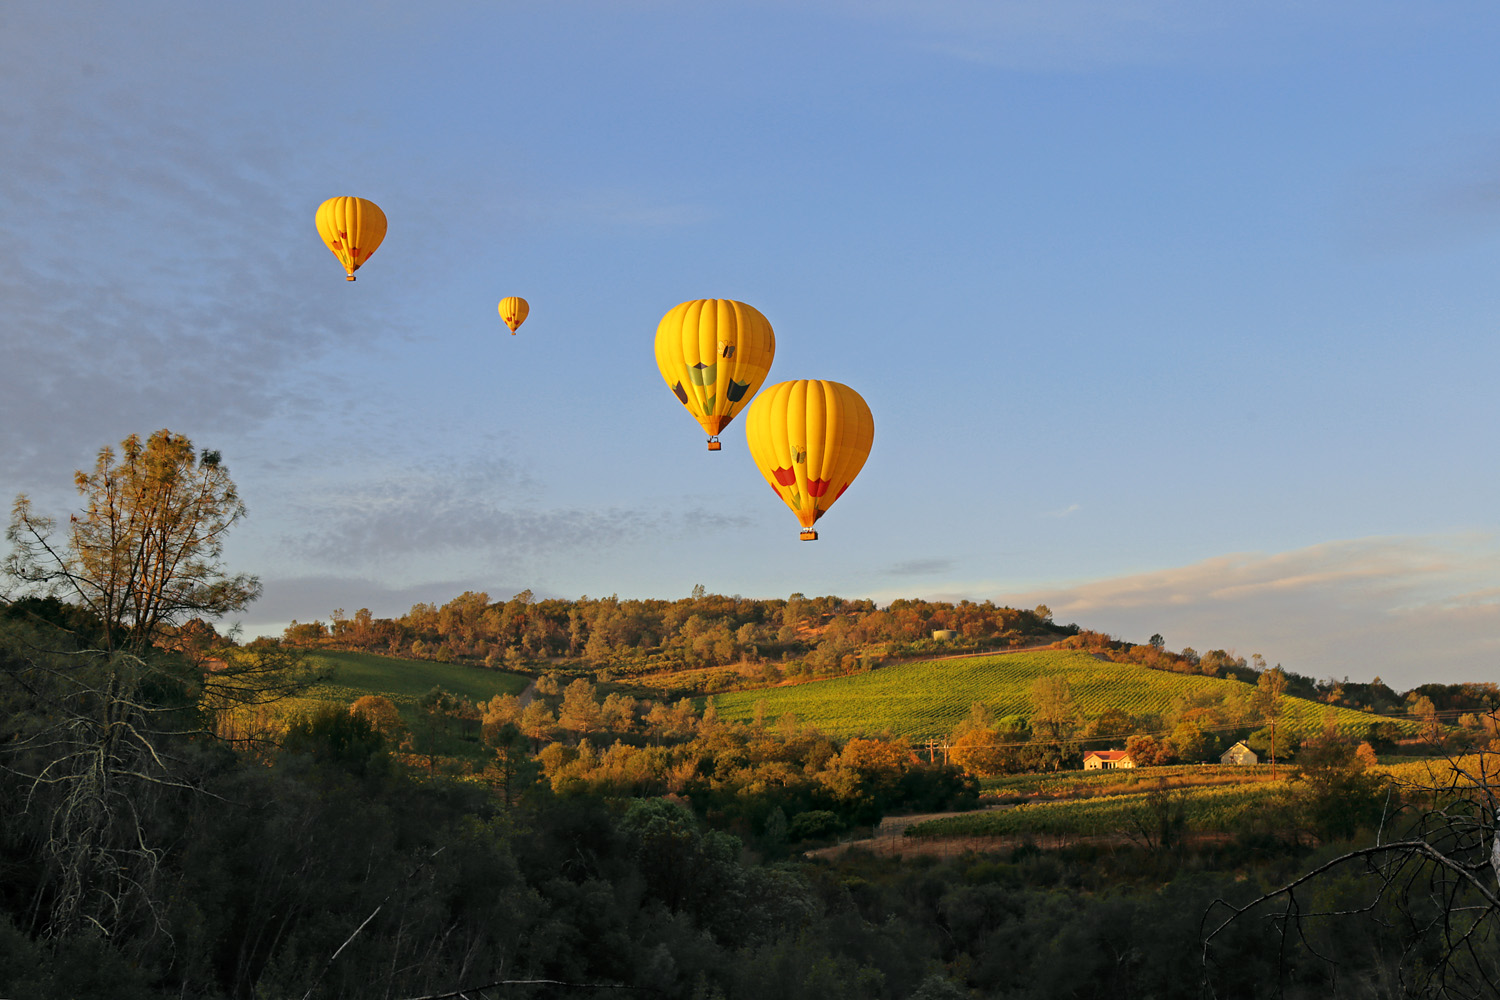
714, 651, 1410, 739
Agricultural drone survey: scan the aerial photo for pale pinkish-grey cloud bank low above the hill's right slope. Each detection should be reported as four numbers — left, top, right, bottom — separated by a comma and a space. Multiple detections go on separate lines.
996, 534, 1500, 687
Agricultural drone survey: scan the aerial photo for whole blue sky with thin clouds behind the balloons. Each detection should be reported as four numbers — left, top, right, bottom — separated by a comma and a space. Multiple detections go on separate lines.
0, 0, 1500, 687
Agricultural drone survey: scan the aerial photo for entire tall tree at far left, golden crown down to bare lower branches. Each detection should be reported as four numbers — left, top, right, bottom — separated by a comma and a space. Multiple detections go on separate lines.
0, 430, 268, 936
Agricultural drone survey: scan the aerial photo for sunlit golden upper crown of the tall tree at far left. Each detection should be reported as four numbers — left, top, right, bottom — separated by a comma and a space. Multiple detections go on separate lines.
5, 430, 261, 654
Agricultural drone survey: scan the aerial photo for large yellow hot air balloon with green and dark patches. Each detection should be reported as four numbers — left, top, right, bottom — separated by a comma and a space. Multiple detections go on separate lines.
656, 298, 776, 451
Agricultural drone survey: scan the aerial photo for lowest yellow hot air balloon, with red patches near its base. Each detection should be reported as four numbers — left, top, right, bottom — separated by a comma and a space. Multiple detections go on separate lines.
746, 378, 875, 541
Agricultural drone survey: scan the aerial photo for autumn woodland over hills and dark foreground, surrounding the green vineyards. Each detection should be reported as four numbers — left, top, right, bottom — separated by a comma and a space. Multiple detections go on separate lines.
0, 432, 1500, 1000
